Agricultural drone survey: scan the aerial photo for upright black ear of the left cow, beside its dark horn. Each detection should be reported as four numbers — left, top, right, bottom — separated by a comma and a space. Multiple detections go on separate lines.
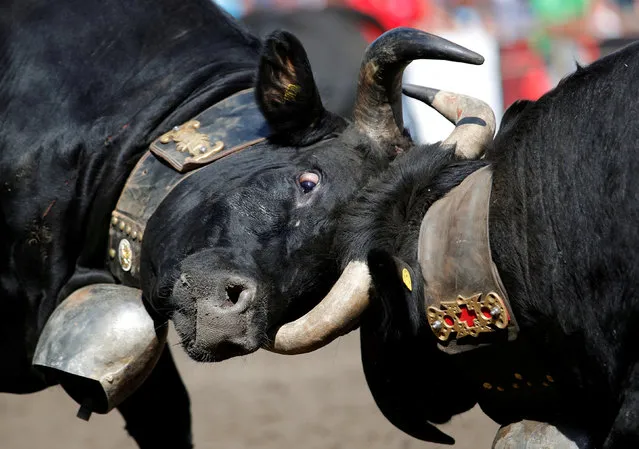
256, 31, 338, 145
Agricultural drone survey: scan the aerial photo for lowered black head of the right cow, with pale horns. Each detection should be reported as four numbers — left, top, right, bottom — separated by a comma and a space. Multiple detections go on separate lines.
278, 82, 495, 444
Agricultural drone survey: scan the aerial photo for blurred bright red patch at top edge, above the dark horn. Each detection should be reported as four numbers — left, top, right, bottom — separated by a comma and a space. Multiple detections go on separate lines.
346, 0, 430, 41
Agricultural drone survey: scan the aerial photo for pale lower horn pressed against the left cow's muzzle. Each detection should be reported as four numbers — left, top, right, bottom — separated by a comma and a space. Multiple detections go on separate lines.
264, 261, 371, 355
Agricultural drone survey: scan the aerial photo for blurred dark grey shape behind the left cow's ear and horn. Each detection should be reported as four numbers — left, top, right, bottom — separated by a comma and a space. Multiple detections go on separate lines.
242, 6, 385, 117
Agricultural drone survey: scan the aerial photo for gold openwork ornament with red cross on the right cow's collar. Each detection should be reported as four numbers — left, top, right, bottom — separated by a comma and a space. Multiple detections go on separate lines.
427, 292, 509, 341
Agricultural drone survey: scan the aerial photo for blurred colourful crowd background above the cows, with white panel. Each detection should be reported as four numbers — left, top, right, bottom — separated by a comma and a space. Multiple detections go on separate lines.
228, 0, 639, 142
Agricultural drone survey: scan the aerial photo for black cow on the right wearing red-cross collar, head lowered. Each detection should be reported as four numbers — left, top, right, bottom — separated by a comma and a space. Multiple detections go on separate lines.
304, 44, 639, 449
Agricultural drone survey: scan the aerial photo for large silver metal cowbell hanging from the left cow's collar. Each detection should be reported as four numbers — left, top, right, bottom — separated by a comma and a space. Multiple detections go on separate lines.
32, 284, 168, 419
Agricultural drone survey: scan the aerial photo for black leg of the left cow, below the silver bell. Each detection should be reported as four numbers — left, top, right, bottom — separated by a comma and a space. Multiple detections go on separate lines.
118, 345, 193, 449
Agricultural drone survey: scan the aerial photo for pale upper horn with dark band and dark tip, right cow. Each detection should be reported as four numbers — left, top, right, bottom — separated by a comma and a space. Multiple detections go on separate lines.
402, 84, 496, 159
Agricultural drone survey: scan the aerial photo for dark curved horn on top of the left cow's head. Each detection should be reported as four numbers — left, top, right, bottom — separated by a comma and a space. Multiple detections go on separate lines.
353, 28, 484, 145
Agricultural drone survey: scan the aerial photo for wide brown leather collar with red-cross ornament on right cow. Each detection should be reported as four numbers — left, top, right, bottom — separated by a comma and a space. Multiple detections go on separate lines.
418, 166, 518, 354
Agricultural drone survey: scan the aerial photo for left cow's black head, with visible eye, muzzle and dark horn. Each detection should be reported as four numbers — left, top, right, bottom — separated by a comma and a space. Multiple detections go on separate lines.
141, 29, 490, 361
